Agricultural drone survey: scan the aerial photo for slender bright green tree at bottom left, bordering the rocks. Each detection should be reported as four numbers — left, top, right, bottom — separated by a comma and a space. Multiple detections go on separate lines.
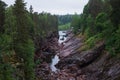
23, 40, 35, 80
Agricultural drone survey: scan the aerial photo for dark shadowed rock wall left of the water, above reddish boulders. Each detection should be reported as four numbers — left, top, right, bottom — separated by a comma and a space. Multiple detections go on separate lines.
35, 32, 59, 63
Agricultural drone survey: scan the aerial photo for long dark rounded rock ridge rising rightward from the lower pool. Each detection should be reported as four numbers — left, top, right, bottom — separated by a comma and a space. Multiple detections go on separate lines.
56, 43, 105, 69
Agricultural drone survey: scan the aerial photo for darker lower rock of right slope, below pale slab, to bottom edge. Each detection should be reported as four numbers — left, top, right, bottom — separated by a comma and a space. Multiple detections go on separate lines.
56, 31, 120, 80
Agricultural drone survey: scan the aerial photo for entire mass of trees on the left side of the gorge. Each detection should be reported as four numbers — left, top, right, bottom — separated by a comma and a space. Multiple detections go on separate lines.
0, 0, 58, 80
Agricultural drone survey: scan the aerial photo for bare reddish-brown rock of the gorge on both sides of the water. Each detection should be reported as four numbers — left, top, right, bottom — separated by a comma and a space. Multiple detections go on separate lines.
35, 31, 120, 80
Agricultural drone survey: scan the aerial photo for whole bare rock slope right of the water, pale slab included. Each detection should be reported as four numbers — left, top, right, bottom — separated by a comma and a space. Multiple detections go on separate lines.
49, 31, 120, 80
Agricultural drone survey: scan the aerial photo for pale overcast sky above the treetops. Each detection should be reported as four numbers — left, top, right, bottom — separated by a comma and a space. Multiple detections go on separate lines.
3, 0, 88, 14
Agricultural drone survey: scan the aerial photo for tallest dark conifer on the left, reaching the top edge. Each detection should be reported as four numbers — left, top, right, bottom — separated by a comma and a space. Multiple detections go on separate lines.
14, 0, 29, 42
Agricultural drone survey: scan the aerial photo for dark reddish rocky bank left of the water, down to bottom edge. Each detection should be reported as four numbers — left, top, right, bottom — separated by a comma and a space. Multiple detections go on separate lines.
34, 32, 59, 80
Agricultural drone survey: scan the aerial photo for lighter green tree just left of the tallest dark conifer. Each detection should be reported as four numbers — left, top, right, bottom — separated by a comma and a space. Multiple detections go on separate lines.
4, 6, 17, 48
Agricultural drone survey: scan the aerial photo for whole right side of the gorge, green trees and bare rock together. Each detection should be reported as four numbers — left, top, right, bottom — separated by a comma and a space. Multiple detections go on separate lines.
54, 0, 120, 80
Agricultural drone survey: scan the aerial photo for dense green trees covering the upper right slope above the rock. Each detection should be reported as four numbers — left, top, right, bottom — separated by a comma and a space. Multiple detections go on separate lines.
71, 0, 120, 55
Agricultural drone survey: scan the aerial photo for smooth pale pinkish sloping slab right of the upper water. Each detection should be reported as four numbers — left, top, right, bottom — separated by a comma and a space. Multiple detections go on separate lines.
59, 31, 82, 58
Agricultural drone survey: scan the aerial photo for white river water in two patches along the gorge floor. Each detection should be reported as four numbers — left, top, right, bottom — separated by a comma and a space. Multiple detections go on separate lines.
50, 31, 67, 72
